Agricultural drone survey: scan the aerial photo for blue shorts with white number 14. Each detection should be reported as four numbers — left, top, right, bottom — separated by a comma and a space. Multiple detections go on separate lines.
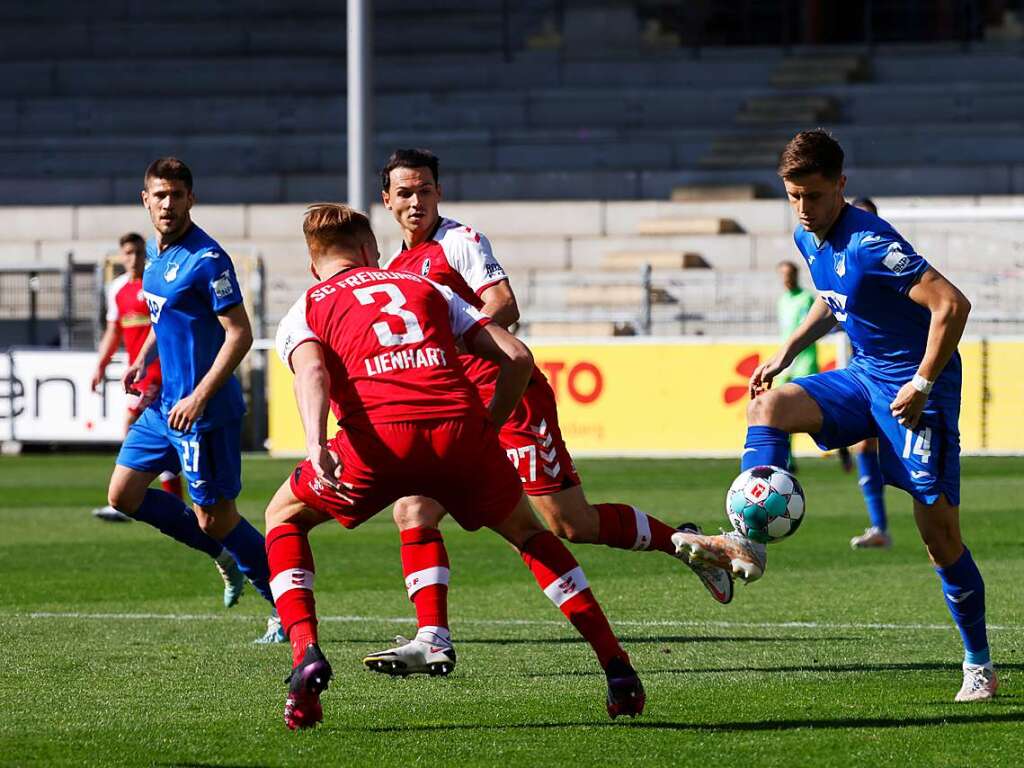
793, 368, 959, 507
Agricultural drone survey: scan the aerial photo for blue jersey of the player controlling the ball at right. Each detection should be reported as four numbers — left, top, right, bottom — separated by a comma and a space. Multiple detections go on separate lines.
794, 205, 961, 394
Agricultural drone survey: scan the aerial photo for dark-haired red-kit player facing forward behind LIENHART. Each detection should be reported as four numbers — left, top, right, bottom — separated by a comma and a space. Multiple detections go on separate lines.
364, 150, 733, 673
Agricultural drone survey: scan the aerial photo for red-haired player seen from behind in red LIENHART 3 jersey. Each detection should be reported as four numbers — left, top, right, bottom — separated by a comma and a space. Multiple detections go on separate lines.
266, 204, 644, 729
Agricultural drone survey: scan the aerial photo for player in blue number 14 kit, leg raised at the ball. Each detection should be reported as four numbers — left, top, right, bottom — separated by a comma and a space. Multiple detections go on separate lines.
673, 130, 997, 701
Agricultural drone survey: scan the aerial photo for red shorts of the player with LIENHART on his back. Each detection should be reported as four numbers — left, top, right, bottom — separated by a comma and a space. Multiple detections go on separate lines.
291, 416, 522, 530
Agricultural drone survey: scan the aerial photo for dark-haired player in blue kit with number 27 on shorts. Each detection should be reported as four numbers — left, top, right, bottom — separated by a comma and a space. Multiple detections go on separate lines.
108, 158, 284, 642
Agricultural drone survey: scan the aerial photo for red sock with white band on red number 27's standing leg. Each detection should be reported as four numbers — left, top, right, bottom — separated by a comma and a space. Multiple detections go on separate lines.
401, 527, 449, 630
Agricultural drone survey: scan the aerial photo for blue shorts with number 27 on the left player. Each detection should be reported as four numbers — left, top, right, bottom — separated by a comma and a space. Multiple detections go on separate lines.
117, 408, 242, 506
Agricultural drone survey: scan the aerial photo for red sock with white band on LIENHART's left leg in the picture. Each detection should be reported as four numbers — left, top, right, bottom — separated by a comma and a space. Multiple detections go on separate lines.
266, 523, 316, 666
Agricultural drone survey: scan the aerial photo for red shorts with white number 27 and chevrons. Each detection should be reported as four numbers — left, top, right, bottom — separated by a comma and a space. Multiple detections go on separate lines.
499, 378, 580, 496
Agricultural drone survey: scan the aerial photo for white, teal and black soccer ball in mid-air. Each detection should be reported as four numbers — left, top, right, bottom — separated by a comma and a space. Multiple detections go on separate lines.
725, 466, 804, 544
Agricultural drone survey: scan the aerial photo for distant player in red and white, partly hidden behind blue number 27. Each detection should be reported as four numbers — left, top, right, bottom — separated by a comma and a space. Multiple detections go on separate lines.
92, 232, 181, 522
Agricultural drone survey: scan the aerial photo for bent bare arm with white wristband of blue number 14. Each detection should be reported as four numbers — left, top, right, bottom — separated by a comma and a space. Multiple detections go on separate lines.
890, 266, 971, 429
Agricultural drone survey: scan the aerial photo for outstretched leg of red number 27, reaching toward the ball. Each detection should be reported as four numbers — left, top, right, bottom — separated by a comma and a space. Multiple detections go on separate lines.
530, 493, 732, 603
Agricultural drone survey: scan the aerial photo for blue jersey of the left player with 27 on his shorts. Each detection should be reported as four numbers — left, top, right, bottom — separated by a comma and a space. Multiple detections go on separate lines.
142, 224, 246, 430
